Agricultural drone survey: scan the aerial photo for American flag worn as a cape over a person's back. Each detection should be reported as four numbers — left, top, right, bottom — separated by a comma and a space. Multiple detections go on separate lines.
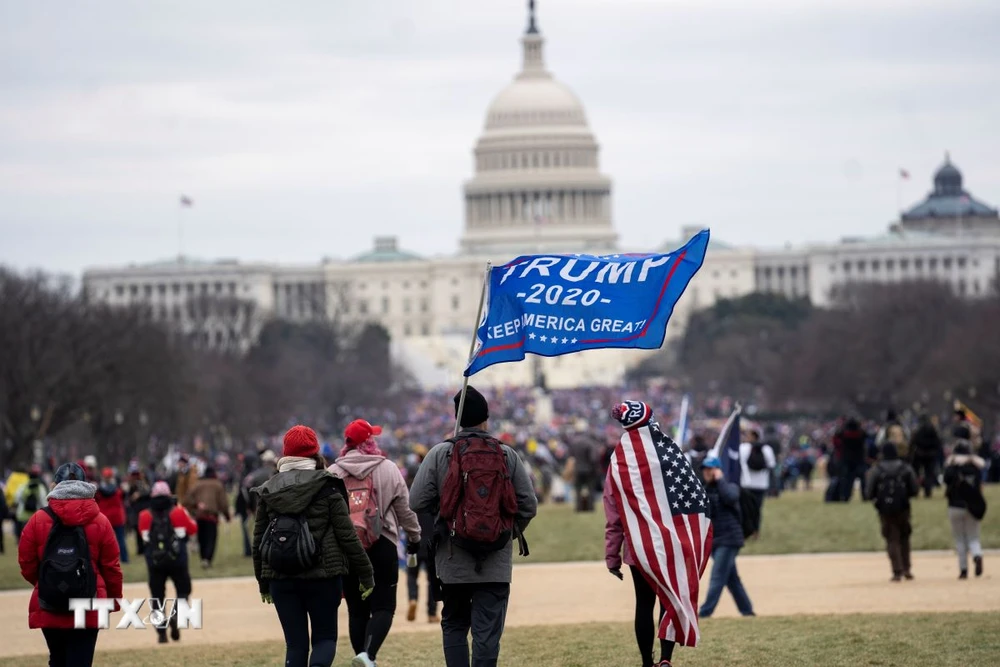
610, 422, 712, 646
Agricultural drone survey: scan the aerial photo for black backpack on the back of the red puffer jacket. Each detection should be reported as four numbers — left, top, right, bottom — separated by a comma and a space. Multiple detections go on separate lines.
38, 507, 97, 612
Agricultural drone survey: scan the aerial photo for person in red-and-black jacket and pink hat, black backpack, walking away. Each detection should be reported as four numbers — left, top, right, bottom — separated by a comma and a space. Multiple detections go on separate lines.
139, 481, 198, 644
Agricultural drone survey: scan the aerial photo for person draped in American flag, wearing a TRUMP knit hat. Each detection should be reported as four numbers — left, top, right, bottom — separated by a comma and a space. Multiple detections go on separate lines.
604, 401, 713, 667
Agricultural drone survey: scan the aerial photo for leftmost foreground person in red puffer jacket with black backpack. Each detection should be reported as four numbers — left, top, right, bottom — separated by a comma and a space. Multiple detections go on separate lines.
17, 463, 122, 667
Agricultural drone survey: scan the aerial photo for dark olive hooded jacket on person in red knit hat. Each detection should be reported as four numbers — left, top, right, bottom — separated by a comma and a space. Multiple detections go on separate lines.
253, 470, 375, 593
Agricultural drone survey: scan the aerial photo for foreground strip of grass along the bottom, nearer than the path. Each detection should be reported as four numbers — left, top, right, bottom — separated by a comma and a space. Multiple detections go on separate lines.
0, 613, 1000, 667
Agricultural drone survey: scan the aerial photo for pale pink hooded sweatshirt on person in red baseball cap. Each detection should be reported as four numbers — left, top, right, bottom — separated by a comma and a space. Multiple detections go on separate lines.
329, 449, 421, 544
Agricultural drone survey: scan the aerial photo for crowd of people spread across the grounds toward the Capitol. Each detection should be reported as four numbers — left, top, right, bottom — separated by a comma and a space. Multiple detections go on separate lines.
0, 384, 1000, 667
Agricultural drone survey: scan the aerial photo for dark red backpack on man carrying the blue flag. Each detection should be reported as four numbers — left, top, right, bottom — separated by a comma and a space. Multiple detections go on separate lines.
441, 436, 517, 571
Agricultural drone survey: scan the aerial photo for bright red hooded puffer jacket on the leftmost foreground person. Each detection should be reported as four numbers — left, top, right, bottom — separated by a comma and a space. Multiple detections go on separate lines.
17, 480, 122, 629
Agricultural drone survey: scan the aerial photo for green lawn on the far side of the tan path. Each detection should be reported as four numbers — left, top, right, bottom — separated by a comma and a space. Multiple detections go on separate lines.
0, 485, 1000, 589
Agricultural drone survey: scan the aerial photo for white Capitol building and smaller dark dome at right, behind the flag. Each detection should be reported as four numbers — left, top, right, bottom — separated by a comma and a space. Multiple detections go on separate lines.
83, 3, 1000, 387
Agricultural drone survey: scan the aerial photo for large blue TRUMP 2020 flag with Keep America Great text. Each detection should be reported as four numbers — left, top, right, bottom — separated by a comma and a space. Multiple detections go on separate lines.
465, 229, 709, 377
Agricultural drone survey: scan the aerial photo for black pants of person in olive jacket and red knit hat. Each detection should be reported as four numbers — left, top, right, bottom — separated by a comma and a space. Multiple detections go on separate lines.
270, 577, 341, 667
